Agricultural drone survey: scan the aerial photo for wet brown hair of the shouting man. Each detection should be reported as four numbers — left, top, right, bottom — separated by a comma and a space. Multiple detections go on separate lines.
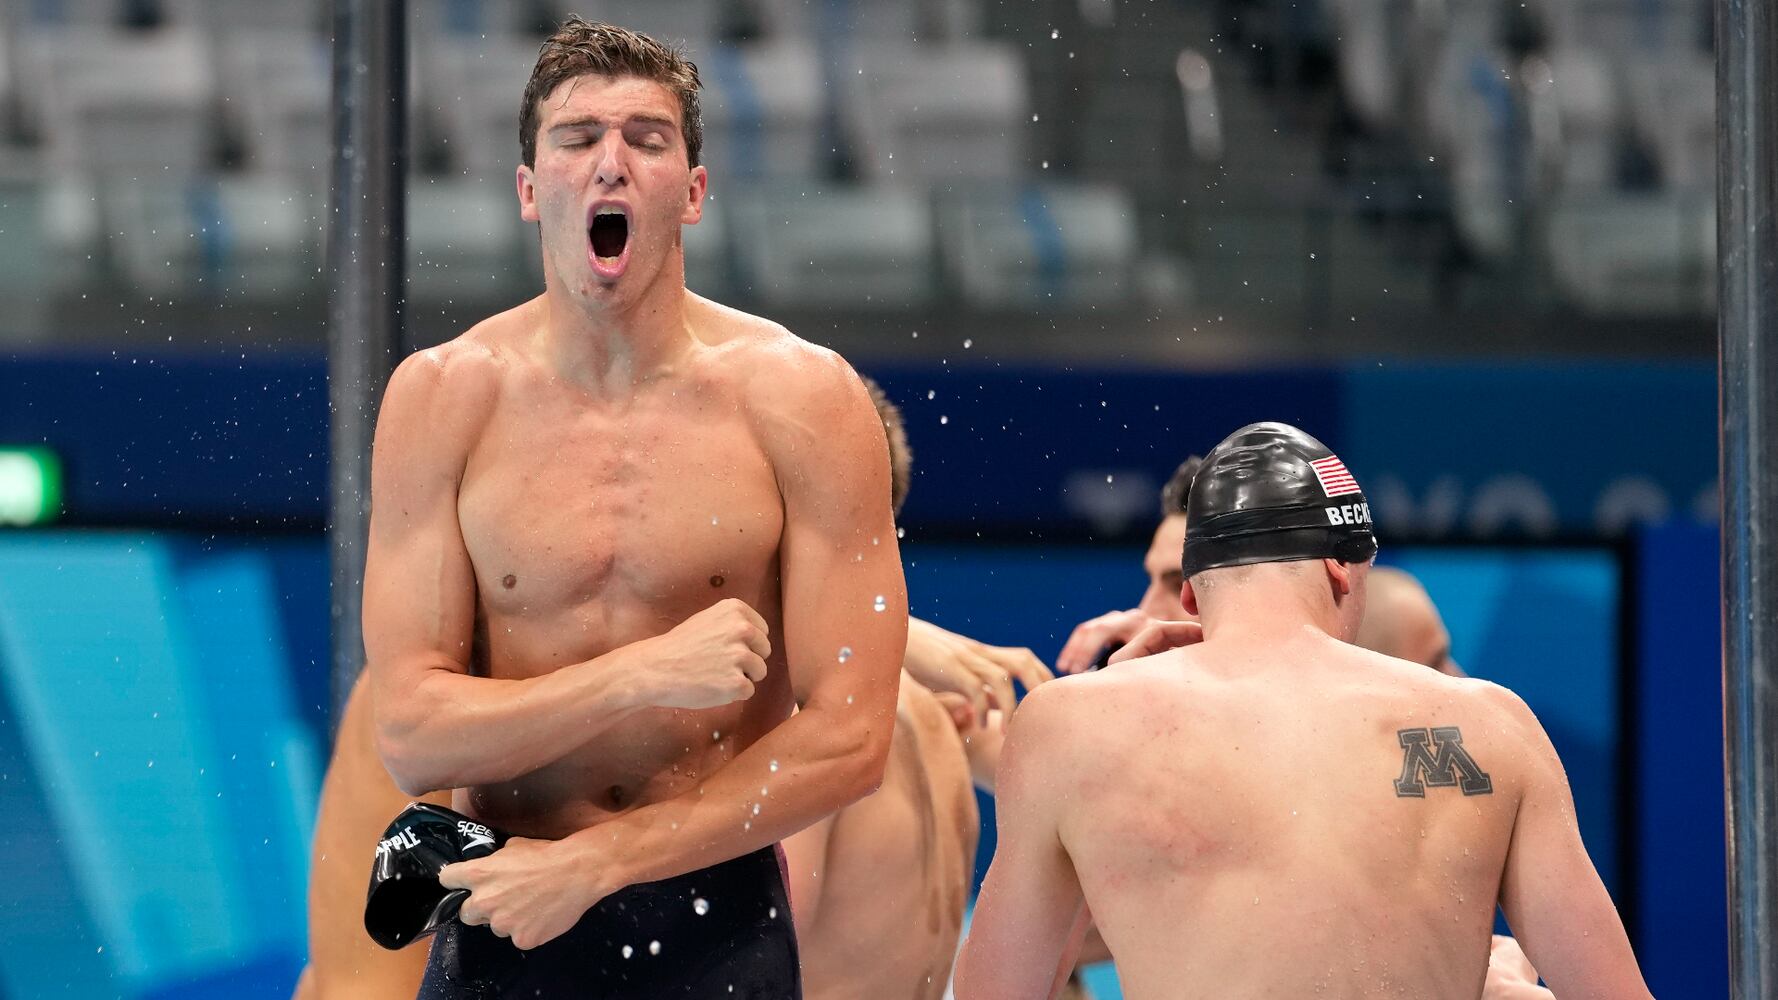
519, 14, 704, 167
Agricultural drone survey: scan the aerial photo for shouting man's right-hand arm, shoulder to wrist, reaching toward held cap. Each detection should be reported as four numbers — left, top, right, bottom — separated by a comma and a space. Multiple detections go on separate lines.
564, 352, 907, 879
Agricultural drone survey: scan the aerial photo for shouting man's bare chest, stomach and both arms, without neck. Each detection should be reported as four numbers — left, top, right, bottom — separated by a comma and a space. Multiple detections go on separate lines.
364, 294, 907, 947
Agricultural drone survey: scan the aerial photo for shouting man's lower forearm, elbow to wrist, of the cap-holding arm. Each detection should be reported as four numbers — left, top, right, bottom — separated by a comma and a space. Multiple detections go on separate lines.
564, 706, 894, 886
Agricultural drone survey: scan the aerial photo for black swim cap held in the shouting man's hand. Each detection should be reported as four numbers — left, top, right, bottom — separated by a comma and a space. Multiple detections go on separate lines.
364, 802, 507, 950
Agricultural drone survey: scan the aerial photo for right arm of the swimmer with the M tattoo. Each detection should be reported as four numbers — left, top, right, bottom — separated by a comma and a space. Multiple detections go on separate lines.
1493, 681, 1648, 1000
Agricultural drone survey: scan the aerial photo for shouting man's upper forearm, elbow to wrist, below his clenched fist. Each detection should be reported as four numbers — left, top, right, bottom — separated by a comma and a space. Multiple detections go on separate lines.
377, 646, 644, 795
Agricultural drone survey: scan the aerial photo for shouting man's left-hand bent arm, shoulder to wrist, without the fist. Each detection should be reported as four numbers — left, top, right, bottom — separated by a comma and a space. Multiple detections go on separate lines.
364, 349, 650, 795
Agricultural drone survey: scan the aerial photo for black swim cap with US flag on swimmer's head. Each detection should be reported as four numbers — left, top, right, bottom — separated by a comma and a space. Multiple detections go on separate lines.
1182, 423, 1376, 578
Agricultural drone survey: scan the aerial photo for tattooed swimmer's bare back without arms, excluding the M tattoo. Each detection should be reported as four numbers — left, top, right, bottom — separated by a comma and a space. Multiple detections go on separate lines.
1061, 639, 1520, 1000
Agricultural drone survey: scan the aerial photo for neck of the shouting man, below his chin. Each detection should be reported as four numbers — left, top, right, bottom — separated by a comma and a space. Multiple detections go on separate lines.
539, 256, 697, 395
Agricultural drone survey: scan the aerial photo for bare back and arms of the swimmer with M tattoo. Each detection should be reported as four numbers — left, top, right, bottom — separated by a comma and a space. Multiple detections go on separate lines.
957, 630, 1648, 1000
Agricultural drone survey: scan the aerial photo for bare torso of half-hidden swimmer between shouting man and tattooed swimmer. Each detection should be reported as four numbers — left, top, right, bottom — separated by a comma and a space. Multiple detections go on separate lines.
793, 674, 980, 1000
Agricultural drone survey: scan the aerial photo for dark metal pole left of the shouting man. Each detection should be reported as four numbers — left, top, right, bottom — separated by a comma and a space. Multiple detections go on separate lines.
327, 0, 407, 726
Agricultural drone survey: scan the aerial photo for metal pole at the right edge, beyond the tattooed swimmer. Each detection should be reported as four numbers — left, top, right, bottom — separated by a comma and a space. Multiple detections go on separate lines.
1716, 0, 1778, 1000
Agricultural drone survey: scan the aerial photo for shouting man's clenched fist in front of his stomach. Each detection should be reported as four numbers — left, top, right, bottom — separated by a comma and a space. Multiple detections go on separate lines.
637, 598, 772, 708
